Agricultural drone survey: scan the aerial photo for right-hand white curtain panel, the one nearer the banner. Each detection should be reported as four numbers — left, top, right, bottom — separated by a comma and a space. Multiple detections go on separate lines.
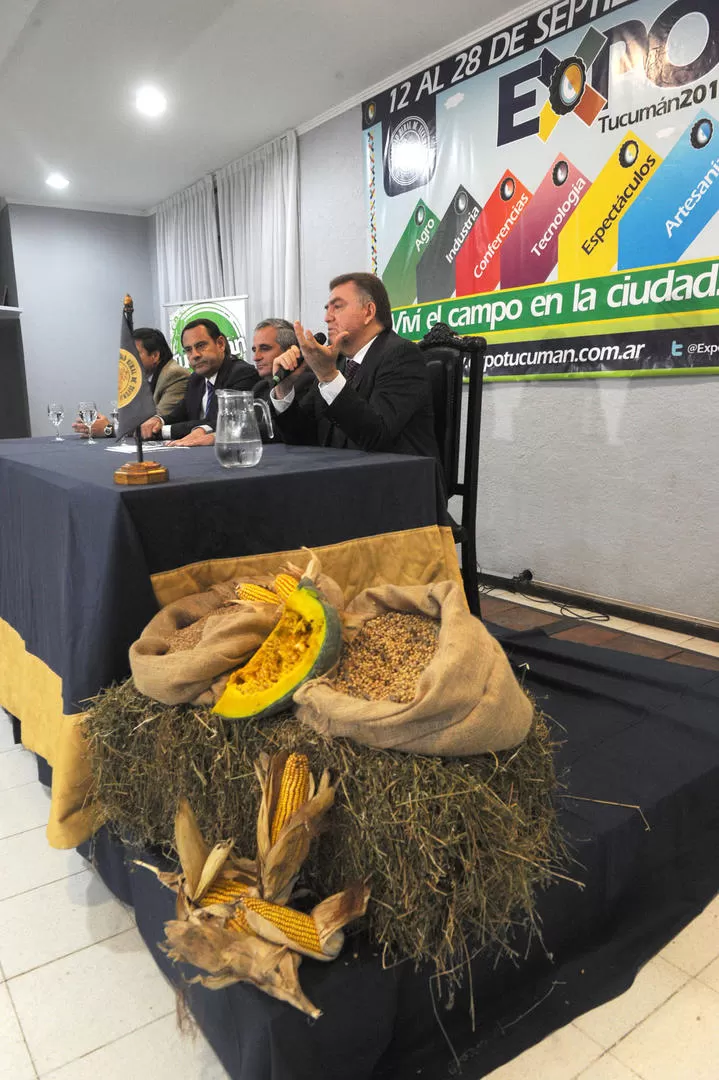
215, 132, 300, 333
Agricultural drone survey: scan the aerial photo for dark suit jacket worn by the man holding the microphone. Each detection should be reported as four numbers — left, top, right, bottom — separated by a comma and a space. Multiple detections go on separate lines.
275, 330, 439, 459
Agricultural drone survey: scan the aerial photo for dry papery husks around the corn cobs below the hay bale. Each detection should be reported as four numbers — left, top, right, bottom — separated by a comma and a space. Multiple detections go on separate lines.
136, 752, 369, 1017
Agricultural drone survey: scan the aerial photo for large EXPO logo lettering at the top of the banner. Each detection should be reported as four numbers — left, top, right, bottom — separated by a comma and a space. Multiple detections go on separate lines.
497, 0, 719, 146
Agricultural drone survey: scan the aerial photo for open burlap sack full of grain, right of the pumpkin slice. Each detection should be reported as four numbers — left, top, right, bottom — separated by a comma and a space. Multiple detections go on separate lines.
295, 581, 532, 757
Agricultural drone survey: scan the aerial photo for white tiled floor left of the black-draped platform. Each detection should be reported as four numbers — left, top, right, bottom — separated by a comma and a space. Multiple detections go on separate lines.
0, 710, 227, 1080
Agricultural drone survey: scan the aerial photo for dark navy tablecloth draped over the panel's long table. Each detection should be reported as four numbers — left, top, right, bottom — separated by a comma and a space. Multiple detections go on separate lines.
0, 438, 437, 713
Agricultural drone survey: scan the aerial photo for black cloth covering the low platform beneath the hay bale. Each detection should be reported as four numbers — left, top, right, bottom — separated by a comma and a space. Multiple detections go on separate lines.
82, 627, 719, 1080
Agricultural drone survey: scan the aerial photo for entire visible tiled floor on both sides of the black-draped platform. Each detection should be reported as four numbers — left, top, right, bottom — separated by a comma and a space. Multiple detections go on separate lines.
0, 591, 719, 1080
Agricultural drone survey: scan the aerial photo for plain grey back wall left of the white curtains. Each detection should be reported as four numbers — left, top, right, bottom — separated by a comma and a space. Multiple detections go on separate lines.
10, 204, 157, 435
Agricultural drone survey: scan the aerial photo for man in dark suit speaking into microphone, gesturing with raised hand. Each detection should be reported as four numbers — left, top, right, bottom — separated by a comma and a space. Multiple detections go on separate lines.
270, 273, 439, 458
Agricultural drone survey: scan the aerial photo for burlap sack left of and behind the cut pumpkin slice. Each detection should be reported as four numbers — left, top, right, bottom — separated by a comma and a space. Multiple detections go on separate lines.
130, 559, 343, 705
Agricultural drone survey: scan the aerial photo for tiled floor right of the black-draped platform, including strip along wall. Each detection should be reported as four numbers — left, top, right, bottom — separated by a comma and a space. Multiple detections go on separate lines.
472, 590, 719, 1080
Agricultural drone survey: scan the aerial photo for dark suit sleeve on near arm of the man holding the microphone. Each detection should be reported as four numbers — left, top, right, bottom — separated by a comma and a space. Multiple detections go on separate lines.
325, 341, 430, 451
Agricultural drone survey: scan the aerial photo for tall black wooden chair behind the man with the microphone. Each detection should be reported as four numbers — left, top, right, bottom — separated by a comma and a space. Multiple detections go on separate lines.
419, 323, 487, 618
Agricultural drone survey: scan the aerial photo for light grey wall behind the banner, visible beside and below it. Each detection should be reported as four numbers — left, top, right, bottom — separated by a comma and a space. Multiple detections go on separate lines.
300, 108, 719, 619
